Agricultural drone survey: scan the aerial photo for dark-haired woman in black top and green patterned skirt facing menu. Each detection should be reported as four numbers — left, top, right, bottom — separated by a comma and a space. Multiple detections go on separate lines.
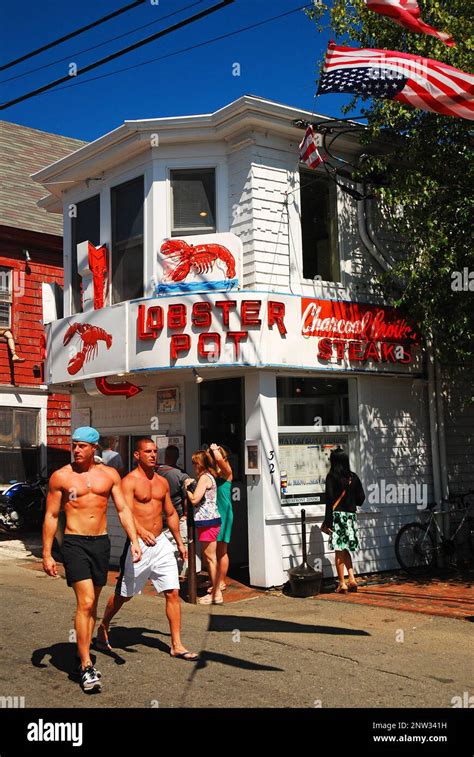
321, 448, 365, 594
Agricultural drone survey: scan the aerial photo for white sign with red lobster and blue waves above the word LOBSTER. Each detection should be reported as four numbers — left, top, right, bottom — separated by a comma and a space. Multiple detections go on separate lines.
155, 233, 242, 296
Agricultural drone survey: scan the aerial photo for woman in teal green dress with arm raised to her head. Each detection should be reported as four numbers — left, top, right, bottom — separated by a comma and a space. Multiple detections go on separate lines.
210, 443, 234, 591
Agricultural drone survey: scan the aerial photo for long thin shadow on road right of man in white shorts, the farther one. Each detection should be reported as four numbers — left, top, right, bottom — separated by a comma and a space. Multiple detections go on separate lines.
208, 615, 370, 636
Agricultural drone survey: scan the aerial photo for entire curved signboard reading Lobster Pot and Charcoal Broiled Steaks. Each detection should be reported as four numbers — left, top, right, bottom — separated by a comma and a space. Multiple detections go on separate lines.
46, 290, 423, 384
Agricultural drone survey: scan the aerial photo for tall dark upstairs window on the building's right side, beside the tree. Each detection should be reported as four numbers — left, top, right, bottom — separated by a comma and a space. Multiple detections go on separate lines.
300, 169, 341, 281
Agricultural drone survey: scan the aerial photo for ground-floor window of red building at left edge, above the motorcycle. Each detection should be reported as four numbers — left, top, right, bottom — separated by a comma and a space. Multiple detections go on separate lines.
0, 407, 39, 484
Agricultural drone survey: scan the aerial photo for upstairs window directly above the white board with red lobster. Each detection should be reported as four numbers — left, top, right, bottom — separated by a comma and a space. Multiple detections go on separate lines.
171, 168, 216, 237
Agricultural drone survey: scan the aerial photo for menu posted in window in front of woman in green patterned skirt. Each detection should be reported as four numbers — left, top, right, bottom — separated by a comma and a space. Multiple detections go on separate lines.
278, 434, 348, 505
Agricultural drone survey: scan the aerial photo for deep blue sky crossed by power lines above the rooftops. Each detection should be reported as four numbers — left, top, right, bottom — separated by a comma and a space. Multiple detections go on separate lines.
0, 0, 348, 140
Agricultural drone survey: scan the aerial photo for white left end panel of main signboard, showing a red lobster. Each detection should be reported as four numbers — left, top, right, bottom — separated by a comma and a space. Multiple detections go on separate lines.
46, 304, 127, 383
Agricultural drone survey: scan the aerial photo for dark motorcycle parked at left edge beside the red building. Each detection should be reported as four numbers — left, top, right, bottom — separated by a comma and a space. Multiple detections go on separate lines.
0, 476, 48, 531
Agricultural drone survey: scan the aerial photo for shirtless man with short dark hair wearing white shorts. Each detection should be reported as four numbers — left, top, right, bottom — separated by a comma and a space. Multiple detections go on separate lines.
97, 437, 199, 662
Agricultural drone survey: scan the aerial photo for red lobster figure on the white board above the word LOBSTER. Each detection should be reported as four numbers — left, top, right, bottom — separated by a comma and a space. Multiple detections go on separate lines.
160, 239, 235, 281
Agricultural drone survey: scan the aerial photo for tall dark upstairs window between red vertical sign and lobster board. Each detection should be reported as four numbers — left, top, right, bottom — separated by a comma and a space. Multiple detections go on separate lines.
111, 176, 145, 304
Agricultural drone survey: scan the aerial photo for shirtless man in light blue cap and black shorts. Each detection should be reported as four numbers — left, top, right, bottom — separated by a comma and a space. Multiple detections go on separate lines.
43, 426, 141, 692
